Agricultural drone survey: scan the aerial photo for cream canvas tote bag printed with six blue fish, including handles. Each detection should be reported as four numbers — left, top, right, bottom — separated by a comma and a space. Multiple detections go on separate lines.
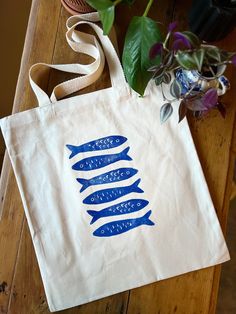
1, 15, 229, 311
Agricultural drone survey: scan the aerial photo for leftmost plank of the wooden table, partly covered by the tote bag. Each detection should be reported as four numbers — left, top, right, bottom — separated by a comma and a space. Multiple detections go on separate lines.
0, 0, 60, 313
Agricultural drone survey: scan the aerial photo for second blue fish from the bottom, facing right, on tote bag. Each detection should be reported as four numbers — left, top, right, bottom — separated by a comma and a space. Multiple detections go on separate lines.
87, 199, 149, 225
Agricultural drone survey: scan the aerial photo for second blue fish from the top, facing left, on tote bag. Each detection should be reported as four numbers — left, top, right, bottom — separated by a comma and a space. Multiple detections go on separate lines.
72, 147, 132, 171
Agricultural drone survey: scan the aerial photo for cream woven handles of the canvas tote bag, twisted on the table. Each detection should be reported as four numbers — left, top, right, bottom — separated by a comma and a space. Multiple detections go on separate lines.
29, 12, 128, 106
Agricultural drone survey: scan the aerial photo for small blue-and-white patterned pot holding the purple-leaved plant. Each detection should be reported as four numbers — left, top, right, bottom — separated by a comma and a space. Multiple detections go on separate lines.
175, 66, 230, 96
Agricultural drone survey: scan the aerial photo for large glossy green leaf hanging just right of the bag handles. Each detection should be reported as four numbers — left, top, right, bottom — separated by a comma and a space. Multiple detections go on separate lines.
122, 16, 161, 96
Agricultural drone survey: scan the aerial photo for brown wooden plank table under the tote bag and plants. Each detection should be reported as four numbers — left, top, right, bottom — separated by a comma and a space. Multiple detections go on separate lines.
0, 0, 236, 314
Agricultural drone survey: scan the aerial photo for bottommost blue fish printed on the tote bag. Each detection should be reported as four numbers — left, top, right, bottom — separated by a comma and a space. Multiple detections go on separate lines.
93, 210, 155, 237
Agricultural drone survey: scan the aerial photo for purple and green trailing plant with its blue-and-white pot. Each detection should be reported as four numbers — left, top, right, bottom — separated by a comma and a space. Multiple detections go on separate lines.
149, 23, 236, 122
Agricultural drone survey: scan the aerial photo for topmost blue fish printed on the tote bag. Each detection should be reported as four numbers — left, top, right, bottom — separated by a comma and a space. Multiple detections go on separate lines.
66, 135, 127, 159
